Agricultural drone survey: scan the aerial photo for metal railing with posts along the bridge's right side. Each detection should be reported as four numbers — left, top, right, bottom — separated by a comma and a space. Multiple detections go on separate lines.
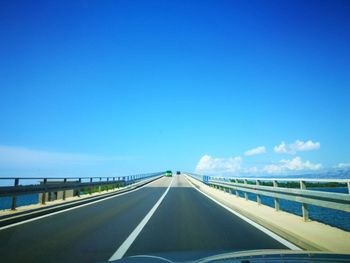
186, 173, 350, 221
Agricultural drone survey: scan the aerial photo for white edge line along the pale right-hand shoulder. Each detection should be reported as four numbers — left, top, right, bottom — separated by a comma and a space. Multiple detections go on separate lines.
185, 176, 302, 250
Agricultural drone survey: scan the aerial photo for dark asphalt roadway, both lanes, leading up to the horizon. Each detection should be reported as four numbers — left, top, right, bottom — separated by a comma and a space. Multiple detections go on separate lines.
0, 175, 286, 262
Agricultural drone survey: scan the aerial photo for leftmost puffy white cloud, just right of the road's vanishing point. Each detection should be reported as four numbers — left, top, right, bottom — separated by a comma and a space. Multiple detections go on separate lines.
196, 154, 242, 174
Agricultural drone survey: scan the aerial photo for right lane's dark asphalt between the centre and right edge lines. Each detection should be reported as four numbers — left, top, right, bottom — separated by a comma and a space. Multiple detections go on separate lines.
126, 176, 286, 260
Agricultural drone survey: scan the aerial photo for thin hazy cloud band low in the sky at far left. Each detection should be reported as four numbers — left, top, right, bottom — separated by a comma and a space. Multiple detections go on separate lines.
0, 145, 123, 167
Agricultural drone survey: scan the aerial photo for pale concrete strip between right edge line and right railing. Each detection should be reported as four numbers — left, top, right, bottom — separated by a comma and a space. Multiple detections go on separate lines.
186, 176, 350, 253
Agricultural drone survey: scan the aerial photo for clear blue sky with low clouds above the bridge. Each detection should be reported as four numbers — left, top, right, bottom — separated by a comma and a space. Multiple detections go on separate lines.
0, 1, 350, 176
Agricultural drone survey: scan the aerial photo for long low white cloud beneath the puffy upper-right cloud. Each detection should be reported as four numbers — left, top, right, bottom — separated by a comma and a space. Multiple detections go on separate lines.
263, 156, 322, 174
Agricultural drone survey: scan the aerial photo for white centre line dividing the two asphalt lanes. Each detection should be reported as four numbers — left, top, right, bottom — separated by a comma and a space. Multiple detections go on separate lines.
108, 177, 174, 261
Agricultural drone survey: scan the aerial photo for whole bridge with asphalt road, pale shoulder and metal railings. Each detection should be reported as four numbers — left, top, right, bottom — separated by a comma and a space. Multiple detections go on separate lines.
0, 172, 350, 262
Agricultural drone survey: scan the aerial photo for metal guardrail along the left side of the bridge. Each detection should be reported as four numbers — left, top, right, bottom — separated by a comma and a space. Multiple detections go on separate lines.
0, 172, 164, 210
